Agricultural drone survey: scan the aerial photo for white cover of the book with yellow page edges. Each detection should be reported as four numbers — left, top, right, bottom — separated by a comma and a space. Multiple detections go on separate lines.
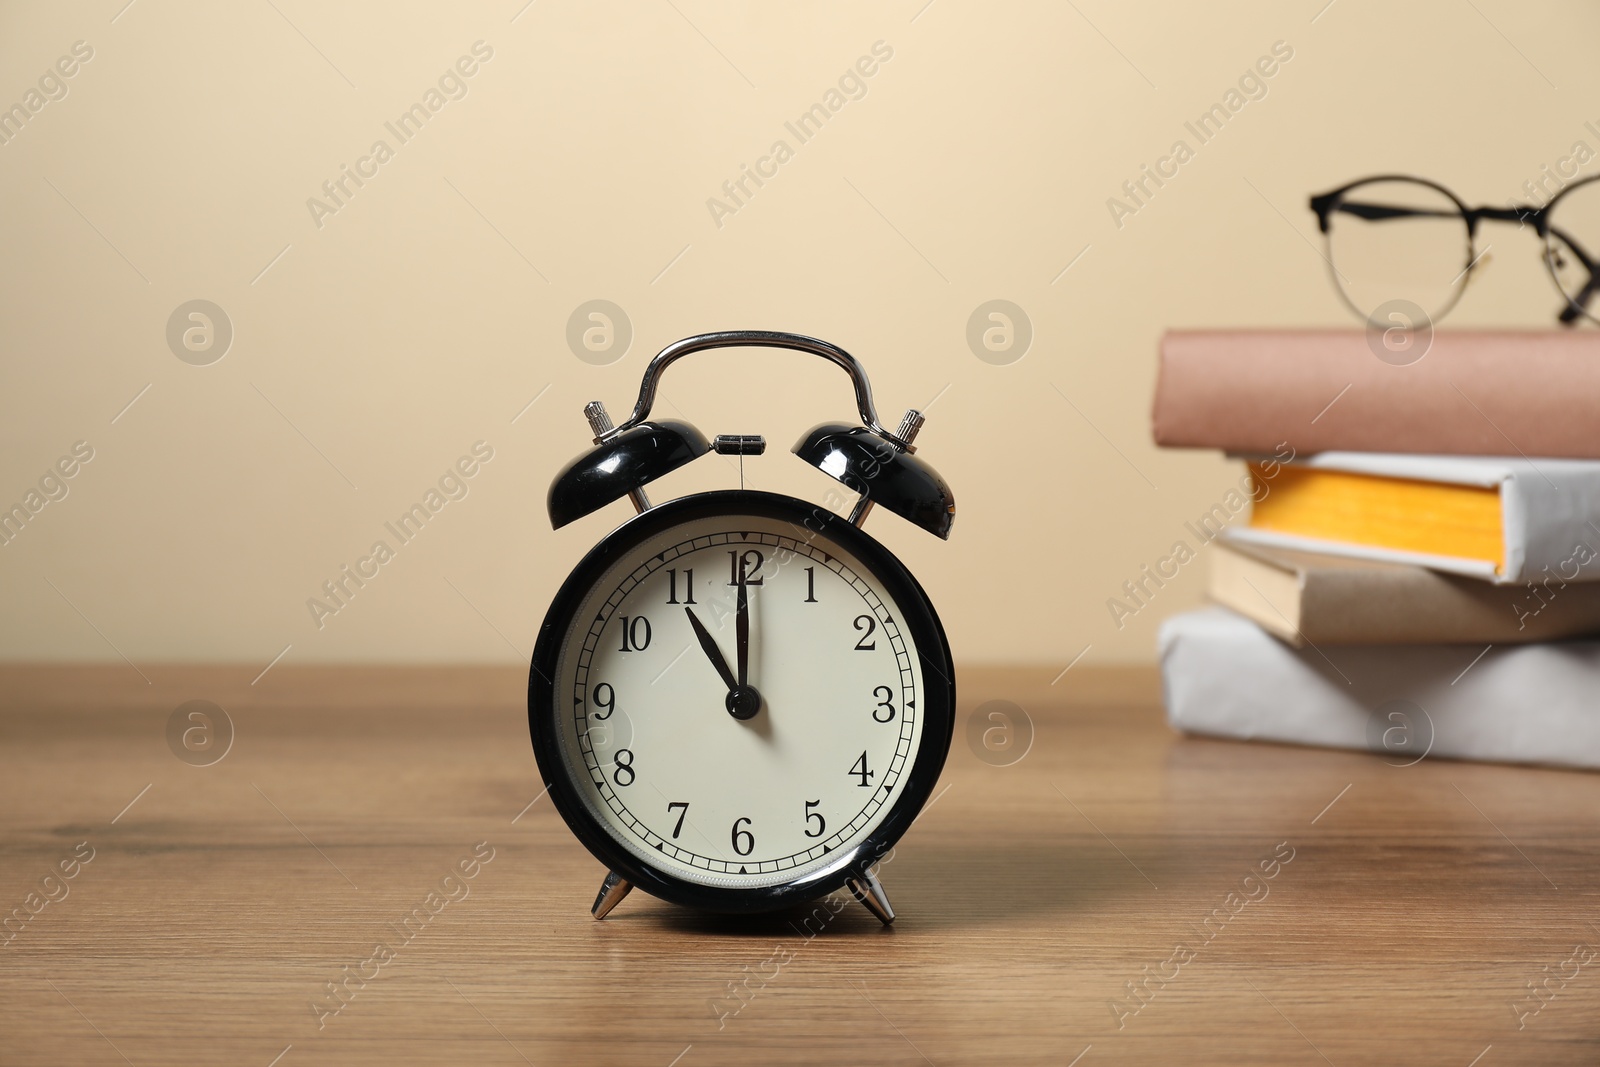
1227, 453, 1600, 585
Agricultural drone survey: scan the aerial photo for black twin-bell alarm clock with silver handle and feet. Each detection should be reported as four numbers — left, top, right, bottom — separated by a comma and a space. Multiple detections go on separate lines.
528, 330, 955, 925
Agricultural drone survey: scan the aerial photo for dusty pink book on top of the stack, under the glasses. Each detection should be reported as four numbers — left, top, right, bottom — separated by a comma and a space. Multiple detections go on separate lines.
1154, 330, 1600, 459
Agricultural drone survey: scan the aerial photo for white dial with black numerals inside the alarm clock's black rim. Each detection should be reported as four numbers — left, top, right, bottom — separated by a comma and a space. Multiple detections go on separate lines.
552, 515, 923, 888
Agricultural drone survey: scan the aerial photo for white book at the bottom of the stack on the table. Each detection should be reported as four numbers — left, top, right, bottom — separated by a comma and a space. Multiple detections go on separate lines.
1158, 608, 1600, 768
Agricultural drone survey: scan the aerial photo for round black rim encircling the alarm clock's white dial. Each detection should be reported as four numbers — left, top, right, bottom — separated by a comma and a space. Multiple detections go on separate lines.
528, 490, 955, 913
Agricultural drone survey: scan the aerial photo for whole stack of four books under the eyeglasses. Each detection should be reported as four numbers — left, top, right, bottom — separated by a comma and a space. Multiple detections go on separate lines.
1154, 331, 1600, 768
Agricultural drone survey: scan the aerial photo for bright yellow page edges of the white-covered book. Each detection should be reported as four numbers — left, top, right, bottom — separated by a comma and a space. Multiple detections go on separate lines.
1250, 464, 1506, 574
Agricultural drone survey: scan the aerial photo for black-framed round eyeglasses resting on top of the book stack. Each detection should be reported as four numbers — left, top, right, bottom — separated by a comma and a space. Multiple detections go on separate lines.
1310, 174, 1600, 330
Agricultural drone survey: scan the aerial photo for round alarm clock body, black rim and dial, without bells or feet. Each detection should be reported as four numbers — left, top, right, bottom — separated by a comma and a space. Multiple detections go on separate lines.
530, 493, 954, 904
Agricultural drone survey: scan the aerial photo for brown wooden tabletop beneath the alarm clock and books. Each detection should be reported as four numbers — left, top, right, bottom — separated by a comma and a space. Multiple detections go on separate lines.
0, 665, 1600, 1067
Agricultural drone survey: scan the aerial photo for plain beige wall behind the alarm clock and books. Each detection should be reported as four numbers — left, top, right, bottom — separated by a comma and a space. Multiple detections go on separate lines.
0, 0, 1600, 665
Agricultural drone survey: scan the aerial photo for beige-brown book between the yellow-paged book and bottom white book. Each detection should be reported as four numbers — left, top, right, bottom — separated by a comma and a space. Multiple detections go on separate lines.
1206, 534, 1600, 648
